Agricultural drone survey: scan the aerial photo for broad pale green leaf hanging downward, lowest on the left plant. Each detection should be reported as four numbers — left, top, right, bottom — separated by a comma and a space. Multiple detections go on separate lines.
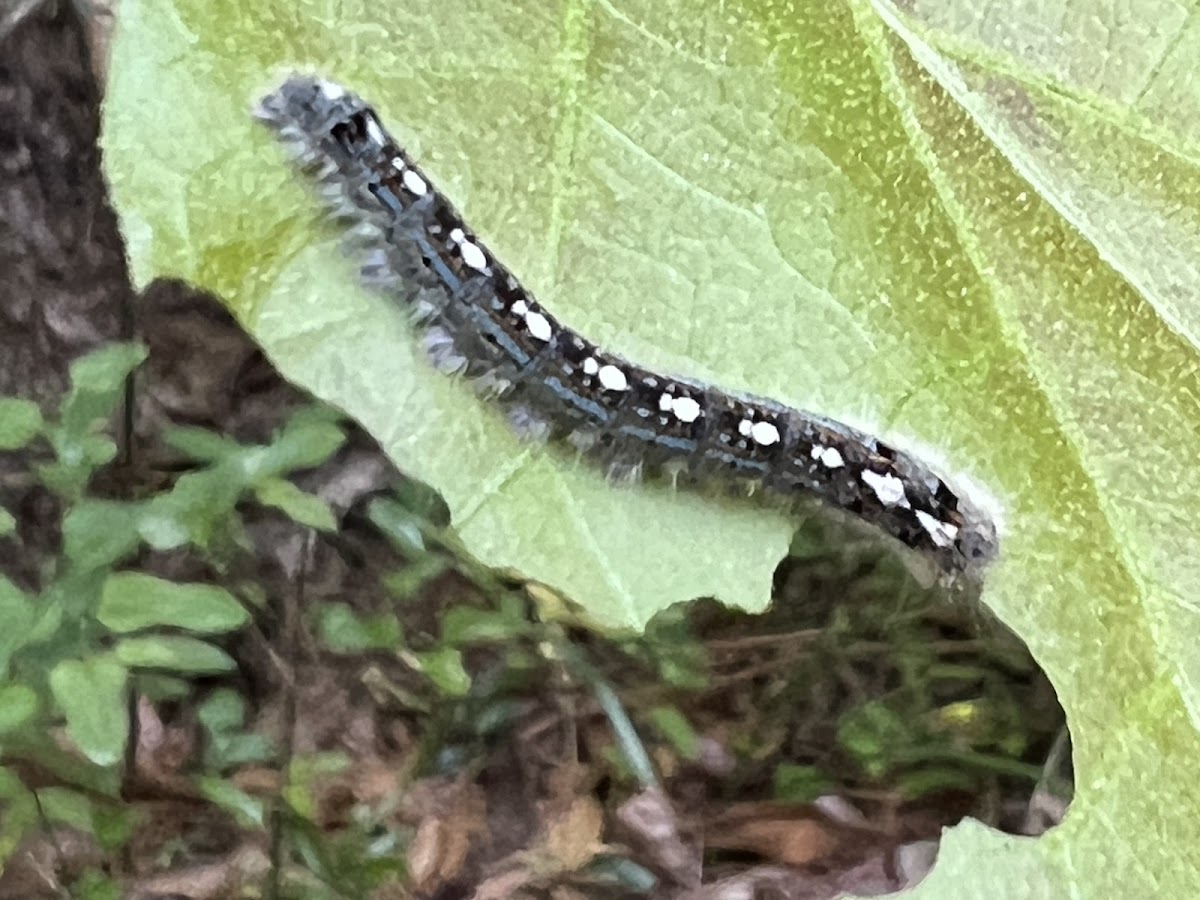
50, 655, 130, 766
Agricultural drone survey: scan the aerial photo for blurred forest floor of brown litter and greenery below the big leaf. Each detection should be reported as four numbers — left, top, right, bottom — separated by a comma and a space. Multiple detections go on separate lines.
0, 284, 1070, 900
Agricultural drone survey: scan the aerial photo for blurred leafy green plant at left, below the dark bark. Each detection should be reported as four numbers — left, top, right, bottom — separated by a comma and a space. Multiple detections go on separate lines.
0, 343, 344, 868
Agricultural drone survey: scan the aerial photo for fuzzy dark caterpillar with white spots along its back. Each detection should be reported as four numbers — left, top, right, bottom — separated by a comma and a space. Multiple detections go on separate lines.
254, 74, 998, 581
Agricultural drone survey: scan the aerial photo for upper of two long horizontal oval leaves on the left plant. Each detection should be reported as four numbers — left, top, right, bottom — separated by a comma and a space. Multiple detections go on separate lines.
96, 572, 250, 634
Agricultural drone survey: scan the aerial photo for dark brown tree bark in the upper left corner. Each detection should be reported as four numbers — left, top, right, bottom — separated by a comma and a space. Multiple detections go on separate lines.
0, 4, 130, 401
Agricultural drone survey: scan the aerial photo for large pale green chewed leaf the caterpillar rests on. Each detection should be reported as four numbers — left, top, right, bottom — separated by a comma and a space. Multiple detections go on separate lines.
104, 0, 1200, 900
